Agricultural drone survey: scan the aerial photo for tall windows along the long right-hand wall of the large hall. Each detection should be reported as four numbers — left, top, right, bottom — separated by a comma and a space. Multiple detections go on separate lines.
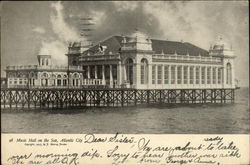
149, 65, 229, 84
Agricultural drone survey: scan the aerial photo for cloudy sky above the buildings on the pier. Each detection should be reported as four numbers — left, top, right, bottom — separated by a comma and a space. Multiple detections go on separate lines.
0, 1, 249, 86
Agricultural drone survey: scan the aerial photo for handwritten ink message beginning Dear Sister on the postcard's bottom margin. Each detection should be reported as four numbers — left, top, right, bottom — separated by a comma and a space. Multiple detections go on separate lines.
6, 133, 242, 165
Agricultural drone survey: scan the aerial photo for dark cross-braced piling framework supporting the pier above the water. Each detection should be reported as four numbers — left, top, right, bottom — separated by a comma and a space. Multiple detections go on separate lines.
1, 89, 235, 109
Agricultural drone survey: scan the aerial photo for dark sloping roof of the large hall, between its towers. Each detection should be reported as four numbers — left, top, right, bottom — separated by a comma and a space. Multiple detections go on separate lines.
82, 36, 208, 56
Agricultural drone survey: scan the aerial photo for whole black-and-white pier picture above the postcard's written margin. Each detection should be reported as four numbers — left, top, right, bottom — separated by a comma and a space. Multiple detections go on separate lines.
0, 1, 250, 135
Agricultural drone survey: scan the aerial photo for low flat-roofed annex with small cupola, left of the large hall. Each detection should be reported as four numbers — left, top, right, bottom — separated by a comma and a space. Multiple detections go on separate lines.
5, 55, 83, 88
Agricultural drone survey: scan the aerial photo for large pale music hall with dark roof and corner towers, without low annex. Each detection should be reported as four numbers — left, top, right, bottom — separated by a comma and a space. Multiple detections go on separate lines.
67, 31, 235, 89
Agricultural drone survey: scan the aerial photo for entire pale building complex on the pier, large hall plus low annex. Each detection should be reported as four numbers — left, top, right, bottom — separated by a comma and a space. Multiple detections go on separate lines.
6, 31, 235, 89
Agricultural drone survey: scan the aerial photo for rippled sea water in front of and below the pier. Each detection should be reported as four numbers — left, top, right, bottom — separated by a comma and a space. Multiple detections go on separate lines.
1, 88, 250, 134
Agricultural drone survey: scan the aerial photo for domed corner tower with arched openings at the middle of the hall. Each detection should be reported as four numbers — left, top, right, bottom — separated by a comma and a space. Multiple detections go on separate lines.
121, 29, 153, 88
